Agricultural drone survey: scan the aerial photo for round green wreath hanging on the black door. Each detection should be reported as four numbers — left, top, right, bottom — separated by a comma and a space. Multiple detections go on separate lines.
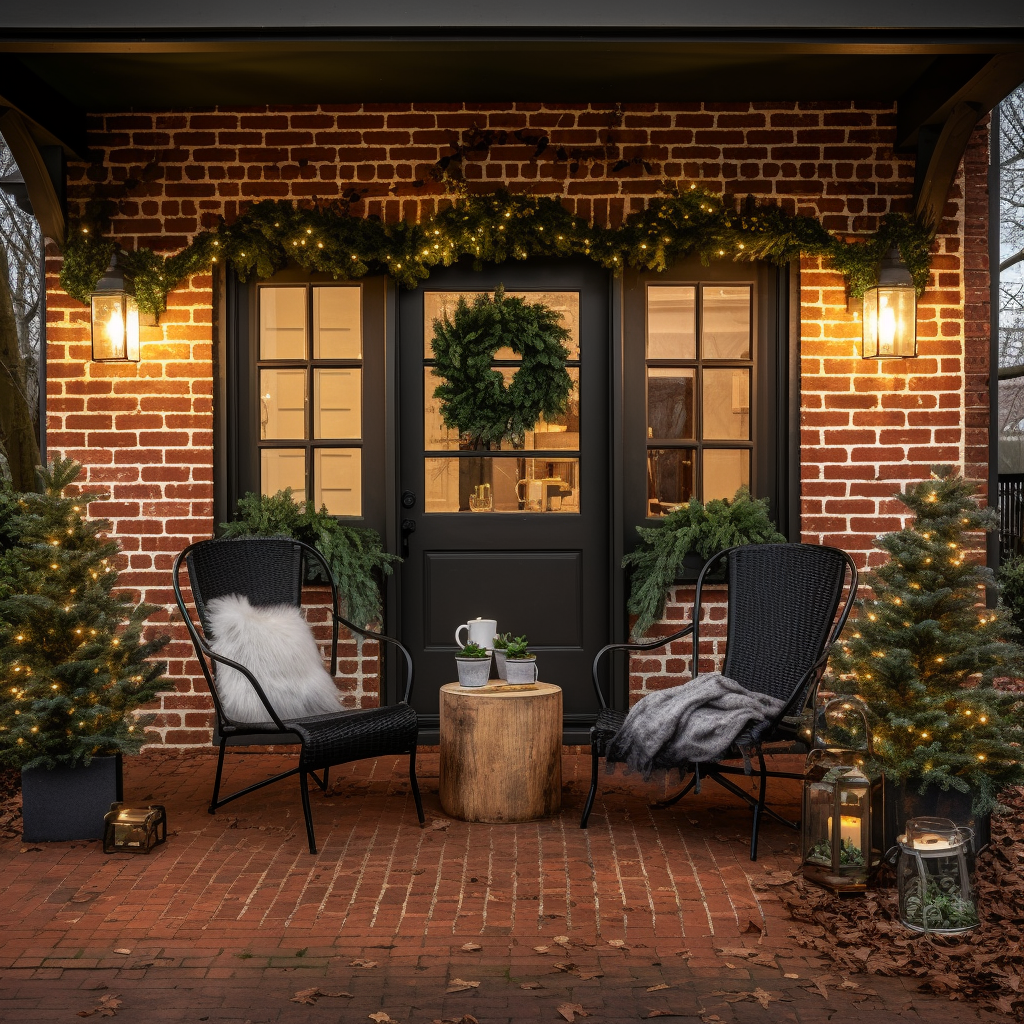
430, 285, 572, 449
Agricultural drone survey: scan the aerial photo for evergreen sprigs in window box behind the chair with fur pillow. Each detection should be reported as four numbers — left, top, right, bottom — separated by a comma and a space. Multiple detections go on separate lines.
220, 487, 401, 626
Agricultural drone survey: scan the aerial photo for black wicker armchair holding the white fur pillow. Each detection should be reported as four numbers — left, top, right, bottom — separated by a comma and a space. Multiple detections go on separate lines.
173, 537, 423, 853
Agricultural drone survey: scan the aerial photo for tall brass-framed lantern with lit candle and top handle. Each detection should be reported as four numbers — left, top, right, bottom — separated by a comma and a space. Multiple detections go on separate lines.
802, 697, 871, 893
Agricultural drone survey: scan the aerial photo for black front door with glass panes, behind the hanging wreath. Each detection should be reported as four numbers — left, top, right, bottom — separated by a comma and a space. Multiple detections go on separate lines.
398, 261, 612, 738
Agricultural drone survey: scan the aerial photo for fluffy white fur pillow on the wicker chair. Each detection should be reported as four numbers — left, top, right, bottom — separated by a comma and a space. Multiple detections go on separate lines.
207, 594, 342, 722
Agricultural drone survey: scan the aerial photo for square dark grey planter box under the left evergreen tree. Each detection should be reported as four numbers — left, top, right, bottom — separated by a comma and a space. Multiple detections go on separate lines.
22, 754, 124, 843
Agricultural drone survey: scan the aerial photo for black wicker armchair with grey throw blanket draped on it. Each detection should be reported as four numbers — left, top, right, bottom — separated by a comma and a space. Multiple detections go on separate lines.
580, 544, 857, 860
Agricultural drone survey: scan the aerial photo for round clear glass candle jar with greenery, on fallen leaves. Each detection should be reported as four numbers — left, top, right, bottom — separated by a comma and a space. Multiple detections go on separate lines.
896, 818, 978, 935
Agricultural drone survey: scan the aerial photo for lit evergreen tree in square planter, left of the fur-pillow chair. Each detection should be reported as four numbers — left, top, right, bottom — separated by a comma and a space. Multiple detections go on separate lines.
0, 458, 170, 842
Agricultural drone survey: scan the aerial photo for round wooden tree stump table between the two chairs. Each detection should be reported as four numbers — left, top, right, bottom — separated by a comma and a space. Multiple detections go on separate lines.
439, 683, 562, 822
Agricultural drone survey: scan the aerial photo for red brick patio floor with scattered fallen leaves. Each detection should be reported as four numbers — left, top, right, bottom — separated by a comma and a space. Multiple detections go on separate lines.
0, 753, 996, 1024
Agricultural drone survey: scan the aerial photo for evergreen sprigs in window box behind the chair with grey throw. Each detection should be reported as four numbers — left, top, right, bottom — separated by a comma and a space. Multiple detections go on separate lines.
623, 487, 785, 639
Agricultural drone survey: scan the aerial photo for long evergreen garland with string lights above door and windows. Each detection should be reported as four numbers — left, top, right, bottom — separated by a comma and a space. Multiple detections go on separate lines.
60, 185, 932, 314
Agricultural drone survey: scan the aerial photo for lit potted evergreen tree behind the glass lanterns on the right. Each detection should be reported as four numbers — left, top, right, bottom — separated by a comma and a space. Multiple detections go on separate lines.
833, 466, 1024, 848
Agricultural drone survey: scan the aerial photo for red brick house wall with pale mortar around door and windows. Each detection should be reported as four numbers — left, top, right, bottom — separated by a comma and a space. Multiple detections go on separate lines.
47, 102, 988, 743
